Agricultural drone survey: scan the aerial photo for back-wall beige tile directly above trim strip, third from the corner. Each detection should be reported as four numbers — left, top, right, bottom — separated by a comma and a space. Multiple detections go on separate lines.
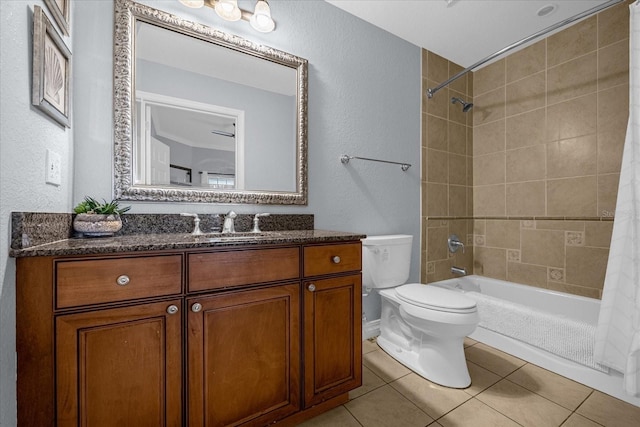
547, 176, 597, 217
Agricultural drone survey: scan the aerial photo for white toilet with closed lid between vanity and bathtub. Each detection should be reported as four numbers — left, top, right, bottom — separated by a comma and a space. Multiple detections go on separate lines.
362, 235, 479, 388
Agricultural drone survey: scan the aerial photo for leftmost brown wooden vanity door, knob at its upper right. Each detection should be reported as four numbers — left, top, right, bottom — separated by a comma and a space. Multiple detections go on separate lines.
56, 299, 182, 427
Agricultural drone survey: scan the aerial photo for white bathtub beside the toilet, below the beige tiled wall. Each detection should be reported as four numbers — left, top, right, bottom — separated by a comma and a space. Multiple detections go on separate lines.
429, 275, 640, 407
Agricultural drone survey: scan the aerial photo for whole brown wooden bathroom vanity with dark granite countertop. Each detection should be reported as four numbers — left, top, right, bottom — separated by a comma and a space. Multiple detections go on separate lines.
14, 226, 364, 426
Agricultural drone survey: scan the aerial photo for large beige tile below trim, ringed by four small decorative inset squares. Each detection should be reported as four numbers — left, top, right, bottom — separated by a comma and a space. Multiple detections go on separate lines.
520, 229, 564, 267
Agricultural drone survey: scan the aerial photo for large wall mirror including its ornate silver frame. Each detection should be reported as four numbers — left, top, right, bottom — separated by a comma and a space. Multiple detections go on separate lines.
114, 0, 308, 205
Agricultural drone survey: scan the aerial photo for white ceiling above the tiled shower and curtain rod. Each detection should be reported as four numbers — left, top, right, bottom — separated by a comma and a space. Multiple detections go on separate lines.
326, 0, 608, 68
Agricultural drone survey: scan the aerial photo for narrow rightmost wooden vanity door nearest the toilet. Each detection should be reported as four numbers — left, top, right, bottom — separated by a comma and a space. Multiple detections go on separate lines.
304, 274, 362, 408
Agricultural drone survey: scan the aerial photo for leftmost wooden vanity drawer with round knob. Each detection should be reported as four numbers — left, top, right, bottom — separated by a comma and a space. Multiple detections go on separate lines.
55, 255, 182, 308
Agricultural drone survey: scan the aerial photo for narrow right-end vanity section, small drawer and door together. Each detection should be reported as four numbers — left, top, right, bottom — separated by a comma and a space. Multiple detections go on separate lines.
303, 243, 362, 408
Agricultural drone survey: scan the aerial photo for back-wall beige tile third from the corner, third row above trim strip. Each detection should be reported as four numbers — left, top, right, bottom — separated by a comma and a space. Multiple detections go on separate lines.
547, 94, 606, 141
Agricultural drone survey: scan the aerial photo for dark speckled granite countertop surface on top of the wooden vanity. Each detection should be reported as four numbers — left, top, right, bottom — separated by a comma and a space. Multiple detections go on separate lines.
11, 230, 366, 257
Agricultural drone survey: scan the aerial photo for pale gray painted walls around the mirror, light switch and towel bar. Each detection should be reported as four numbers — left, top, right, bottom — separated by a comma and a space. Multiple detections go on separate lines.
0, 0, 421, 427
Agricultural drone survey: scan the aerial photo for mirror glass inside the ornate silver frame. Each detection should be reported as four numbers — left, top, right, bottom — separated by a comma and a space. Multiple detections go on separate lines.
134, 22, 297, 191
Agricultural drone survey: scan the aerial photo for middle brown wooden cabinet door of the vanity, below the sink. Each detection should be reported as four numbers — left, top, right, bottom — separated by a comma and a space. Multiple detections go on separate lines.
187, 283, 300, 426
